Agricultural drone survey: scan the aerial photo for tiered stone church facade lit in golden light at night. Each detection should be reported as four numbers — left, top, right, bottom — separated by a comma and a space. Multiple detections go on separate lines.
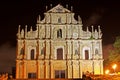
16, 4, 103, 79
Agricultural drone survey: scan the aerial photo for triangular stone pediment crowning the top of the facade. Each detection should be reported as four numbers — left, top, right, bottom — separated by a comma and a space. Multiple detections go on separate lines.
48, 4, 70, 13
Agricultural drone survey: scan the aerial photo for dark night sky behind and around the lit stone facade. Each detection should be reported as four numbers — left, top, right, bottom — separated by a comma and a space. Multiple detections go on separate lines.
0, 0, 120, 72
